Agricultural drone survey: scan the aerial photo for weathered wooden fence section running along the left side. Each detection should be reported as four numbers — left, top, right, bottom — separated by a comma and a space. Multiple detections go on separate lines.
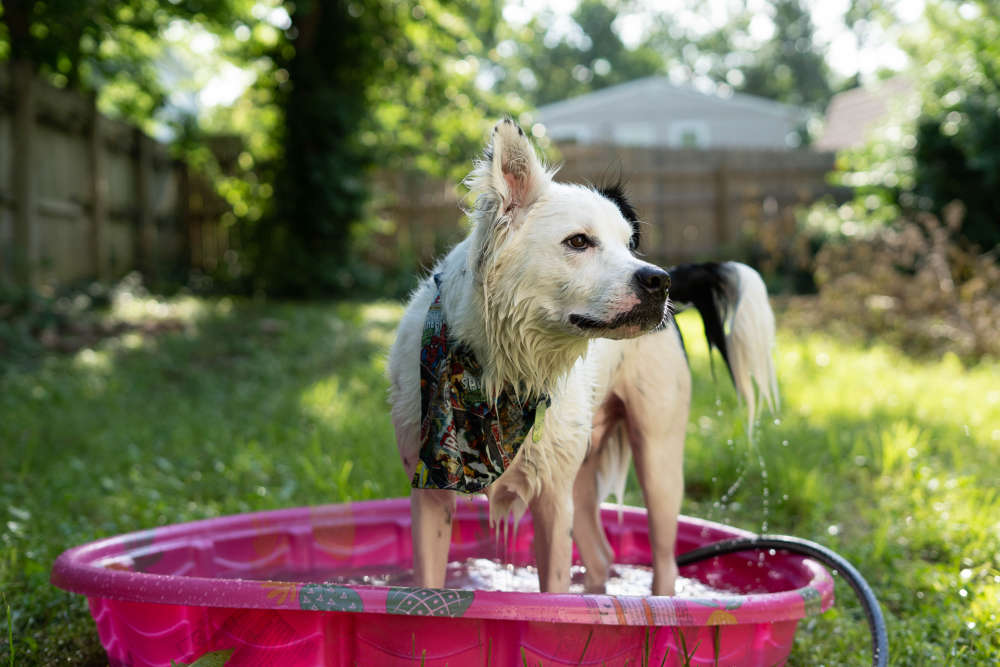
0, 67, 228, 286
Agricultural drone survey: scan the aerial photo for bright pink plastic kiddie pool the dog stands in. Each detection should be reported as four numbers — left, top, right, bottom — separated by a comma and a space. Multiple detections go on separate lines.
52, 498, 833, 667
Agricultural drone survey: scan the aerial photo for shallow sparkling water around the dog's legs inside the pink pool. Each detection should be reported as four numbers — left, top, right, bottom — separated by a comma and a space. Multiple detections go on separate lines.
239, 558, 734, 597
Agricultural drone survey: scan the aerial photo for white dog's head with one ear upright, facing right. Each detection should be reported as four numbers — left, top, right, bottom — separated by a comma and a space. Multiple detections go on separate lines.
466, 119, 670, 338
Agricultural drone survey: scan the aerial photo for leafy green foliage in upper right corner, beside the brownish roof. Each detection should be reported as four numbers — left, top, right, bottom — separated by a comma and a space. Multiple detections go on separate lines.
837, 0, 1000, 250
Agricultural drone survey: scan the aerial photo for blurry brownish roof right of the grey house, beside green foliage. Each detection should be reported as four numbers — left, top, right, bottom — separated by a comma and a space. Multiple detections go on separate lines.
816, 76, 914, 150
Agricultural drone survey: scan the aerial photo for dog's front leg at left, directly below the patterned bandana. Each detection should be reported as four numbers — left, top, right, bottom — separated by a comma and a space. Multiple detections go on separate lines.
410, 489, 455, 588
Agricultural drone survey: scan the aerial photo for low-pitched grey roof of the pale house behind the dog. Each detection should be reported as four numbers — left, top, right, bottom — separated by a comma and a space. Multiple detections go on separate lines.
538, 76, 807, 120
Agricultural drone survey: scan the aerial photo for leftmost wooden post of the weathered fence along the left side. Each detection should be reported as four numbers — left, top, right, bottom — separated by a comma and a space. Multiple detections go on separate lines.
10, 60, 38, 287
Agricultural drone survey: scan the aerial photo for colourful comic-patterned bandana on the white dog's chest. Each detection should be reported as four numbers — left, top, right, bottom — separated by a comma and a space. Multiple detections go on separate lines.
412, 274, 549, 493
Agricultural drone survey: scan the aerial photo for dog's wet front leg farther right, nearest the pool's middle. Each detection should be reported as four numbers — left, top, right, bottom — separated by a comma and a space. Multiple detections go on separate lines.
531, 480, 573, 593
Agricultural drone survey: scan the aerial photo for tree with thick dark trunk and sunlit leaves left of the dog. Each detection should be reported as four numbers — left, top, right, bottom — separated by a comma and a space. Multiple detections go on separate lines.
254, 0, 519, 296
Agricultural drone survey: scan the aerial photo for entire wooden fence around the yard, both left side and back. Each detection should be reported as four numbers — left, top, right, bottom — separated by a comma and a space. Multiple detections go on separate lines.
0, 67, 833, 286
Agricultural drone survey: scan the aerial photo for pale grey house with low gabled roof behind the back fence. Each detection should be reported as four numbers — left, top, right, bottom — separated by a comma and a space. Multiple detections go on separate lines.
536, 76, 807, 150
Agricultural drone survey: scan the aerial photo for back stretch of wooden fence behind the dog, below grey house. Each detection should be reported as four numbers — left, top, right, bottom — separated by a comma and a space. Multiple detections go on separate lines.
375, 145, 843, 272
